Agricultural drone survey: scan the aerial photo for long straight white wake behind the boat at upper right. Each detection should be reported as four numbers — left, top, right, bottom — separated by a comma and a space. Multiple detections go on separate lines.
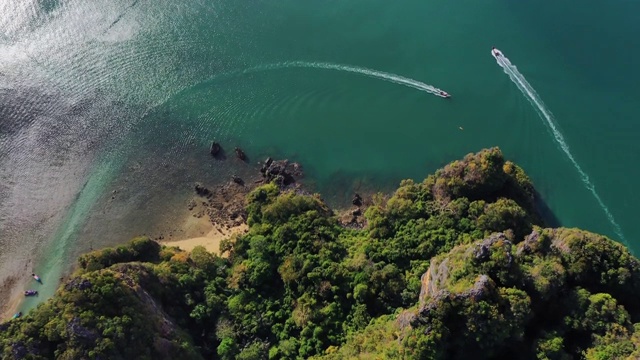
491, 51, 627, 244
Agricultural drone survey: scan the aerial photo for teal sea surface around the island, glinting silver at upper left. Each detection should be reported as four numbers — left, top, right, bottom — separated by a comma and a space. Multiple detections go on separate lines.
0, 0, 640, 310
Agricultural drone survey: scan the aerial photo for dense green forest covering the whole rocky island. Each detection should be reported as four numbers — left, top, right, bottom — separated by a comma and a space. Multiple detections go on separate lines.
0, 148, 640, 359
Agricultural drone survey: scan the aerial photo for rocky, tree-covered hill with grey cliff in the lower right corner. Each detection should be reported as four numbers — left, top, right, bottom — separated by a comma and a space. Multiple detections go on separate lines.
412, 228, 640, 359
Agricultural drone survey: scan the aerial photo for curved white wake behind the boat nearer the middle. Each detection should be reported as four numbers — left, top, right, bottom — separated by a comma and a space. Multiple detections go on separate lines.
243, 61, 450, 97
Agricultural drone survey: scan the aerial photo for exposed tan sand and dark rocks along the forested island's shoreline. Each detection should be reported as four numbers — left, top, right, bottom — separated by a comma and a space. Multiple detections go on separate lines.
0, 156, 372, 321
